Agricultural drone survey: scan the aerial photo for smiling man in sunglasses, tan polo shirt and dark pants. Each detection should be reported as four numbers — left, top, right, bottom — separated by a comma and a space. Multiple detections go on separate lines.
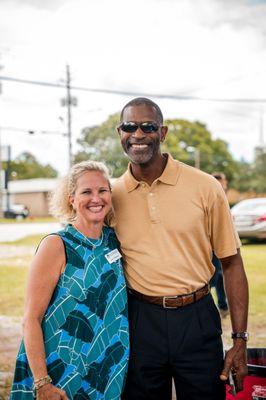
110, 98, 248, 400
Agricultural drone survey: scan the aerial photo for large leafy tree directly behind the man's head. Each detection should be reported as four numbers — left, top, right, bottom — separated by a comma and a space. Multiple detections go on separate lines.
75, 114, 237, 180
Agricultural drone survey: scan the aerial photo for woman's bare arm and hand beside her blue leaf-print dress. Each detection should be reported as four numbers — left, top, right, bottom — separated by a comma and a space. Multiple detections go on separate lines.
23, 235, 67, 399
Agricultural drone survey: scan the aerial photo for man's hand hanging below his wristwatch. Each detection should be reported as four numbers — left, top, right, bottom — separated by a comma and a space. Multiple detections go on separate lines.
220, 339, 248, 392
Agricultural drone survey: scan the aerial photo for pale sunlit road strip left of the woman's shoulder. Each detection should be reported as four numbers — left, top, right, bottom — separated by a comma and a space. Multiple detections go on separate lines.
0, 222, 62, 242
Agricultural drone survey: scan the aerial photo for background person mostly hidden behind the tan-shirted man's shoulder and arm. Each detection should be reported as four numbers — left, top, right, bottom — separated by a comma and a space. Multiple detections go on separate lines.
210, 172, 229, 318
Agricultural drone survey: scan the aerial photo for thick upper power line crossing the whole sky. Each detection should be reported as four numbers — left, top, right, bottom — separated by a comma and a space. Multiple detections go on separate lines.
0, 76, 266, 103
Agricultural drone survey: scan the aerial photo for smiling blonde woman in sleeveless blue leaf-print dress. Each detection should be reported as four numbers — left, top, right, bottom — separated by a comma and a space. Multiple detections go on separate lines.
10, 161, 129, 400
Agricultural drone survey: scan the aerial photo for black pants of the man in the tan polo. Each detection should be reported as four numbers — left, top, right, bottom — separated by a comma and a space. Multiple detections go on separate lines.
122, 294, 225, 400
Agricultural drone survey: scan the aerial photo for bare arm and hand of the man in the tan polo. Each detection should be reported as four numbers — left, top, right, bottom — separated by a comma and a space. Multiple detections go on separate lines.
220, 250, 248, 391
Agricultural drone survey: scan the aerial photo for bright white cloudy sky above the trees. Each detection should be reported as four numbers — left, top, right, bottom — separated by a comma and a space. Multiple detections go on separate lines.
0, 0, 266, 175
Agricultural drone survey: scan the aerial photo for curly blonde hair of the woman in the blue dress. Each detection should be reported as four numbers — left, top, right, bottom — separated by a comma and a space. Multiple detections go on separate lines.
49, 161, 111, 222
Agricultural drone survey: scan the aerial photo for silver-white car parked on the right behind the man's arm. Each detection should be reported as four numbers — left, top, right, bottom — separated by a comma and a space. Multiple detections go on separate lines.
231, 197, 266, 239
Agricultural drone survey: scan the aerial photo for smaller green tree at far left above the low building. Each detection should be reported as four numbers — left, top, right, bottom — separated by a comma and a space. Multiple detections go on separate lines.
3, 152, 57, 180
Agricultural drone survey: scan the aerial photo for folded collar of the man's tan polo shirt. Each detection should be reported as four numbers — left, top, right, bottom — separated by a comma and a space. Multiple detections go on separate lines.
125, 153, 180, 192
